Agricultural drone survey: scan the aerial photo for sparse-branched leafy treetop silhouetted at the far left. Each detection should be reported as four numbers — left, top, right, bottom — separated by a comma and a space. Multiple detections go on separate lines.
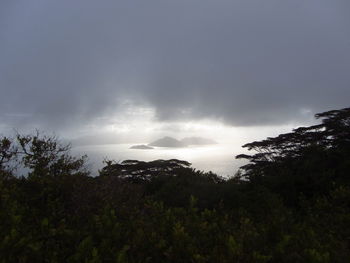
0, 131, 88, 176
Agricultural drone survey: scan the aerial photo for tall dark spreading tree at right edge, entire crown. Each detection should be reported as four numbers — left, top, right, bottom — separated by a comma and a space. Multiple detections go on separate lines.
236, 108, 350, 205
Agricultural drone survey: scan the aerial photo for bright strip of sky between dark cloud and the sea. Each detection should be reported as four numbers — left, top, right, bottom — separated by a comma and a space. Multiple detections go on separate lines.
64, 103, 315, 145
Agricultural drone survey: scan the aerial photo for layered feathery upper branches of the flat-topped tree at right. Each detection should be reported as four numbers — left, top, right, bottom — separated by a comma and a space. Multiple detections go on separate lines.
236, 108, 350, 177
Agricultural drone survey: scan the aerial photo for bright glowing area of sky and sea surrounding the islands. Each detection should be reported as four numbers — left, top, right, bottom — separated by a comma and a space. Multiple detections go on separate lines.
68, 104, 311, 176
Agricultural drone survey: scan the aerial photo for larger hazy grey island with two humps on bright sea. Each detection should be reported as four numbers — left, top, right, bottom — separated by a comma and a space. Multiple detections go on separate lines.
148, 136, 217, 148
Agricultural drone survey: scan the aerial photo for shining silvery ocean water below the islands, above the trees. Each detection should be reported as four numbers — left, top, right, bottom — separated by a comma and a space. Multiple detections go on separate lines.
72, 143, 246, 177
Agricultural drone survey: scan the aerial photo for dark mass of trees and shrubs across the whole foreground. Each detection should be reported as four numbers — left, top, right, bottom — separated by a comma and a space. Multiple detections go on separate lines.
0, 108, 350, 263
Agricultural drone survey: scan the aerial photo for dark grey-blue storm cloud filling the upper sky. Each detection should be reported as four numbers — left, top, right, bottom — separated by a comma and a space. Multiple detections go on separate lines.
0, 0, 350, 131
